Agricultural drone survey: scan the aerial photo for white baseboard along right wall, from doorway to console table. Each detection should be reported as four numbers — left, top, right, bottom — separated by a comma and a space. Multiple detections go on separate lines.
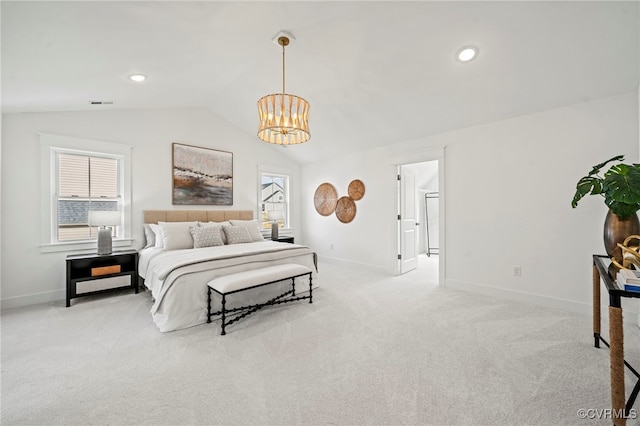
445, 279, 640, 326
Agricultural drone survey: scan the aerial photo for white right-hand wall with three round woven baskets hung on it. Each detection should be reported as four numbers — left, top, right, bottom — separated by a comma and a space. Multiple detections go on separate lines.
302, 91, 639, 312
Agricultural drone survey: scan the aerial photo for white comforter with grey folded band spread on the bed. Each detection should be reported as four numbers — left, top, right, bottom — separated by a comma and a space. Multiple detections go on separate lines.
138, 241, 316, 332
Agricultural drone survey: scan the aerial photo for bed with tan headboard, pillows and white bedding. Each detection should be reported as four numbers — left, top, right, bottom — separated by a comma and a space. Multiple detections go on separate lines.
138, 210, 317, 332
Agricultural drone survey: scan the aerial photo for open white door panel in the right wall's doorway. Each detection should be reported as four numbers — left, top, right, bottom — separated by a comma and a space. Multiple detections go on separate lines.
399, 166, 418, 274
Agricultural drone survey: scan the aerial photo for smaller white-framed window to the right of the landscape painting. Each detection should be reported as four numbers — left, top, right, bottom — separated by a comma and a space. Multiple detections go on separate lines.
260, 170, 291, 230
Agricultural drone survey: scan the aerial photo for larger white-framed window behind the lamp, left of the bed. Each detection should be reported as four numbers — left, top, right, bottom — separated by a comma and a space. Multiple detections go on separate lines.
40, 134, 131, 251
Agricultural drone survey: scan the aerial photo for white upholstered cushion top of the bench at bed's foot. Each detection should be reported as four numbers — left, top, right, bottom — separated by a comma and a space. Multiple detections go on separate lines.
207, 263, 311, 294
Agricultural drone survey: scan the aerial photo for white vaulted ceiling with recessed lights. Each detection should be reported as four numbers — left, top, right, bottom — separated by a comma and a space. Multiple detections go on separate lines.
0, 1, 640, 163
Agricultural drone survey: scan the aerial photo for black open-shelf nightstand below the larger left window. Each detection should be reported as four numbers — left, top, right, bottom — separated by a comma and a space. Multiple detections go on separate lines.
67, 250, 138, 308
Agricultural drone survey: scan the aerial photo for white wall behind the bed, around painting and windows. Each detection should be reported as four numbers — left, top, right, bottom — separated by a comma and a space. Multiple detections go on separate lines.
0, 108, 301, 307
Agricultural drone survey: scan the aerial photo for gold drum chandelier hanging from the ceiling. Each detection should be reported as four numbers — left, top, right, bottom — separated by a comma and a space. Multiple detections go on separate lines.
258, 35, 311, 145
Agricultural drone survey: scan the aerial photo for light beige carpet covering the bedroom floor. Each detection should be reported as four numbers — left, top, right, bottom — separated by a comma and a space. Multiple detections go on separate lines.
1, 256, 640, 425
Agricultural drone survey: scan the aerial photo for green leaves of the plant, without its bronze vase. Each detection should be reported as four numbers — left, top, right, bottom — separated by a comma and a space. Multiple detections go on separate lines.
571, 155, 640, 219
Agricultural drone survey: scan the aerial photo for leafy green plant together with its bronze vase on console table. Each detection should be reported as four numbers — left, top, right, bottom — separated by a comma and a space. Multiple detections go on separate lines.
571, 155, 640, 265
